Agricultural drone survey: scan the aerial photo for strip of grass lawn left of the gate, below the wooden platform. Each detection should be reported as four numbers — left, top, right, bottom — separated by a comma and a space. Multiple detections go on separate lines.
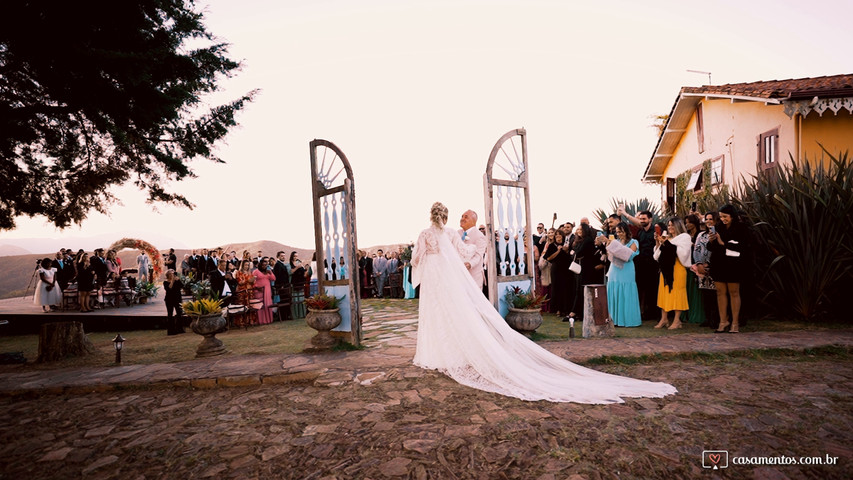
0, 320, 317, 369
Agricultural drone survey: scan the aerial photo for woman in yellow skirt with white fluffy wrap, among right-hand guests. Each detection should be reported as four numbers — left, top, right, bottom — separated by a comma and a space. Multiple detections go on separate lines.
654, 217, 693, 330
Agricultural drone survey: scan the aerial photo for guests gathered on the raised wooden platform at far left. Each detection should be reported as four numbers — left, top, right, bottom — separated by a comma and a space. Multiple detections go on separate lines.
33, 248, 176, 312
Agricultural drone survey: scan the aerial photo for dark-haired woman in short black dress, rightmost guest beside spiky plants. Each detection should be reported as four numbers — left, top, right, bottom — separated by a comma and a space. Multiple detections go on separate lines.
708, 205, 749, 333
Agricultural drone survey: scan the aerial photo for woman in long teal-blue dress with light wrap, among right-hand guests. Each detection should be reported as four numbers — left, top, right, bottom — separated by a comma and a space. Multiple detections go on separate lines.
600, 222, 642, 327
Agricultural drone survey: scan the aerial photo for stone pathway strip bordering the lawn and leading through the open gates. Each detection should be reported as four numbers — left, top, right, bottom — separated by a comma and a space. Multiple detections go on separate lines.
0, 300, 853, 395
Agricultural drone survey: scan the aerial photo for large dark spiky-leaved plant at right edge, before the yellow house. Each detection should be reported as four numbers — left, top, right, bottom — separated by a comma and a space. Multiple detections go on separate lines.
733, 150, 853, 320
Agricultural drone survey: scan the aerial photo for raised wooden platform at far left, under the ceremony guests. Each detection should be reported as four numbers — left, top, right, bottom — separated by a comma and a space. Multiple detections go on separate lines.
0, 295, 166, 335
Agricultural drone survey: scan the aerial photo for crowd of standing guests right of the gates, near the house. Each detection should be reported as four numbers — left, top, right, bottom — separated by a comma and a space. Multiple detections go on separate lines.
533, 205, 751, 333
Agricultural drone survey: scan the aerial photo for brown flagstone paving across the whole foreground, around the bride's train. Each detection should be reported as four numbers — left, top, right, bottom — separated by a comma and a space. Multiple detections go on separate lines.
0, 300, 853, 480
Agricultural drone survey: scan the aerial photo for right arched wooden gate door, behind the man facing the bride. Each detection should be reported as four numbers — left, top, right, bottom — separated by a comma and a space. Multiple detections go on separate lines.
483, 128, 536, 316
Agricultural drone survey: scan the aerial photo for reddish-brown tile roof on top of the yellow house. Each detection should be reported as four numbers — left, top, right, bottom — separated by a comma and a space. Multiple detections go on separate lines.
681, 74, 853, 99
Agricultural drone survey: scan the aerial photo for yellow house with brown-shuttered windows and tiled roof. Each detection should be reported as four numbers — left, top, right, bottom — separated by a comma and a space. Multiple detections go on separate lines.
643, 74, 853, 211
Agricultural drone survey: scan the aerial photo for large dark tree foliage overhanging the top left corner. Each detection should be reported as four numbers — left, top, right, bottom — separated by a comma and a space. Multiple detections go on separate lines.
0, 0, 256, 230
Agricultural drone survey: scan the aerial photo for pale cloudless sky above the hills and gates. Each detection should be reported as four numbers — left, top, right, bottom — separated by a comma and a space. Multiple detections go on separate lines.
0, 0, 853, 253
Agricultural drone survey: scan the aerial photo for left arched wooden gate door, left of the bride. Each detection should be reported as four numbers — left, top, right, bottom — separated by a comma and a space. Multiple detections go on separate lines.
310, 140, 362, 345
